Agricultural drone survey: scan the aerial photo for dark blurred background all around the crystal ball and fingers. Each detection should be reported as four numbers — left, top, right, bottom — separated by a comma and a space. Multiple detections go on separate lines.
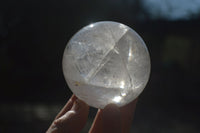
0, 0, 200, 133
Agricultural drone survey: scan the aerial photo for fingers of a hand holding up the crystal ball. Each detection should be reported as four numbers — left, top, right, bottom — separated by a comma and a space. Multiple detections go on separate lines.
46, 95, 137, 133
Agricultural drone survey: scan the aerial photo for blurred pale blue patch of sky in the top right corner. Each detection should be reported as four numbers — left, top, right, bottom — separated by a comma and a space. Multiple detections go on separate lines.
142, 0, 200, 20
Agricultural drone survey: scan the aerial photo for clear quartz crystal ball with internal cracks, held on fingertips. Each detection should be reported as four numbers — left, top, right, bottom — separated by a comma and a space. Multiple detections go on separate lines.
63, 21, 150, 108
